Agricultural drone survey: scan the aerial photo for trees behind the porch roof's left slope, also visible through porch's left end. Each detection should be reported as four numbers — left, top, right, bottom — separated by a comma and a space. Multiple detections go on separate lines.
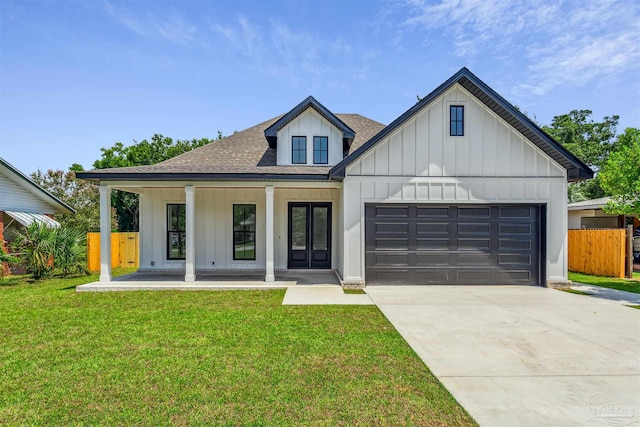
93, 135, 222, 231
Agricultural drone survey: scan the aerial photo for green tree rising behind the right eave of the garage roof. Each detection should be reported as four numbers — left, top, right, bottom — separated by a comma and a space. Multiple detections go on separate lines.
543, 110, 619, 201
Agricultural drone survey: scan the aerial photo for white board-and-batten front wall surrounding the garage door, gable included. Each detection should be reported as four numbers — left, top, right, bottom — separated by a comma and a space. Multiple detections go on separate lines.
342, 85, 567, 281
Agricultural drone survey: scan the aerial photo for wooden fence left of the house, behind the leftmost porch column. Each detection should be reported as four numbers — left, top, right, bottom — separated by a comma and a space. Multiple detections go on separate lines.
87, 233, 140, 271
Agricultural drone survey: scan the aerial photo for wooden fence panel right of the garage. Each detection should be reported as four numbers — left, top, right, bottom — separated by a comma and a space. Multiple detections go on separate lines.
569, 228, 627, 277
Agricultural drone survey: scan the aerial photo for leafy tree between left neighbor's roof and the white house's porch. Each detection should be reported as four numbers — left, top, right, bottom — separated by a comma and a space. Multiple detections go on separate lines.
31, 167, 116, 234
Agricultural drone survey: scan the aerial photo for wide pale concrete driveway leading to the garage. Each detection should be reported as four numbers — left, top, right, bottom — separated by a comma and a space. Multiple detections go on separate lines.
366, 286, 640, 427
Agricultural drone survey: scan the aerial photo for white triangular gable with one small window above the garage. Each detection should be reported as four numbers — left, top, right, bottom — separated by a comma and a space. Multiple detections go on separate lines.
346, 84, 566, 177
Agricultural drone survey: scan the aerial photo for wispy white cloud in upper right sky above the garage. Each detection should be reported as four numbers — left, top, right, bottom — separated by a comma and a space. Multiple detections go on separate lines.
396, 0, 640, 95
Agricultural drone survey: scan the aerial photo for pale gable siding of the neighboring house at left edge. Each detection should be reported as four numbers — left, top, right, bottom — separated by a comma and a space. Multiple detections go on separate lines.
0, 167, 59, 214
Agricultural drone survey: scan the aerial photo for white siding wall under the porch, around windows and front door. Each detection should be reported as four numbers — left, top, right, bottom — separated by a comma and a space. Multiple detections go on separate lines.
140, 186, 340, 271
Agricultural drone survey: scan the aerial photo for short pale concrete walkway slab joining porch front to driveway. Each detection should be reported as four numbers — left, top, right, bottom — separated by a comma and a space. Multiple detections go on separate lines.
282, 286, 373, 305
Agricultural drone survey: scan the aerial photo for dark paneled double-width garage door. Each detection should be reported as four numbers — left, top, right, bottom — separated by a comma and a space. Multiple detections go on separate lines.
365, 204, 544, 285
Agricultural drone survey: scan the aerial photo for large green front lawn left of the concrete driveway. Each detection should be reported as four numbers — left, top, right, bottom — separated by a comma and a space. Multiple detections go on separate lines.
0, 275, 476, 426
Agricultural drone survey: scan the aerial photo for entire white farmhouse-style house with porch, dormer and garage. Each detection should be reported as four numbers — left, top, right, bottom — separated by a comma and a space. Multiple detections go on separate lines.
77, 68, 593, 285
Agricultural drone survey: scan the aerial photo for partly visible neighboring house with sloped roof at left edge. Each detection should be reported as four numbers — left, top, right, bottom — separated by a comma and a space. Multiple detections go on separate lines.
0, 158, 75, 244
